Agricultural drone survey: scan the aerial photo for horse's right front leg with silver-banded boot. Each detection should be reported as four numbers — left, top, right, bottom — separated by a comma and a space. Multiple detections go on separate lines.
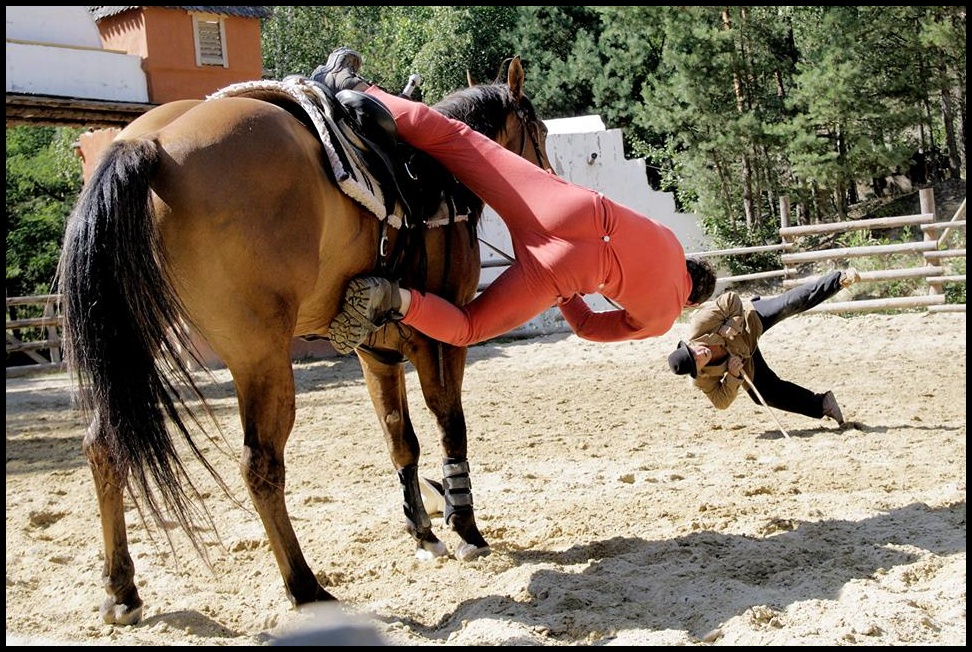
412, 338, 490, 561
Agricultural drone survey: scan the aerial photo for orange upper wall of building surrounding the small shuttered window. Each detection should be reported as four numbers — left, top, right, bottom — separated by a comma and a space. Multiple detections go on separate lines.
98, 7, 263, 104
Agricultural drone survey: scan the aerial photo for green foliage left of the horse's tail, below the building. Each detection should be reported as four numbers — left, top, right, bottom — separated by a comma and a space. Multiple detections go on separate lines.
5, 127, 81, 296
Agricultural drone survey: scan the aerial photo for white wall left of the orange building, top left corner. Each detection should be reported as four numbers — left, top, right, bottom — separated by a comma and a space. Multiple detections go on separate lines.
6, 6, 148, 103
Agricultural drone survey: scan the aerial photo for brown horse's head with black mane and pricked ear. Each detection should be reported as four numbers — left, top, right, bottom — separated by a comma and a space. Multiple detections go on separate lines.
433, 56, 553, 172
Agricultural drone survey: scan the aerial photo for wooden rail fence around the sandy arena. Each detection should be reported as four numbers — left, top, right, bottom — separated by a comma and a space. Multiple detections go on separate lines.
7, 189, 965, 378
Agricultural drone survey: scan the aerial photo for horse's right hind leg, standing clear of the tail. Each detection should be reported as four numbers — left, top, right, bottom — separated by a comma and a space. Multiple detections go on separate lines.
231, 360, 335, 606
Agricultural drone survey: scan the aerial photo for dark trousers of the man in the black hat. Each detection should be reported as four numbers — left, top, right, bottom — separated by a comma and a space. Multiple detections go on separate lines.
746, 271, 841, 419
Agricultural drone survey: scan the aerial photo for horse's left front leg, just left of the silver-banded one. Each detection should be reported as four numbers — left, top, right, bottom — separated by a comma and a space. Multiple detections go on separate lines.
358, 348, 449, 559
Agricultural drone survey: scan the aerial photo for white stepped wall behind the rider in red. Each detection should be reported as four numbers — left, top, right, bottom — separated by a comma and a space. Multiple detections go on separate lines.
479, 116, 710, 335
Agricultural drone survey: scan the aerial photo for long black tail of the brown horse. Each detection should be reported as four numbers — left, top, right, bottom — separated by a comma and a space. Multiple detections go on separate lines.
59, 139, 226, 557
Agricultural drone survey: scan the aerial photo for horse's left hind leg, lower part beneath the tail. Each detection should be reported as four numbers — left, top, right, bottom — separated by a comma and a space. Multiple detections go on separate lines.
82, 414, 142, 625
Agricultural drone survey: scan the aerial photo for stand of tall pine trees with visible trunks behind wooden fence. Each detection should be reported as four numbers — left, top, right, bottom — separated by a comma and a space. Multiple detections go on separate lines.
572, 6, 965, 258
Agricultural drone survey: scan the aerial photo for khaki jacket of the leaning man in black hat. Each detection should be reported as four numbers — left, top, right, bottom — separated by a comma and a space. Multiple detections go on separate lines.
688, 292, 763, 410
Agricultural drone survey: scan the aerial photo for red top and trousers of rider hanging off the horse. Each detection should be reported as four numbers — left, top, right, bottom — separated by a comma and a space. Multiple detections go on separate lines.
367, 86, 692, 346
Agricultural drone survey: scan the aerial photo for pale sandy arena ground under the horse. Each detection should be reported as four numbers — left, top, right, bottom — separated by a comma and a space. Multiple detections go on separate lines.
6, 312, 967, 646
